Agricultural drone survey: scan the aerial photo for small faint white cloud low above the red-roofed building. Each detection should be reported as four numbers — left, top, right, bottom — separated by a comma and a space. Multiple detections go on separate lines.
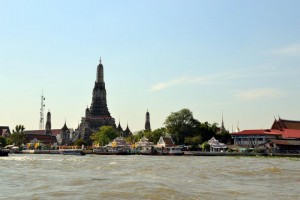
236, 88, 282, 100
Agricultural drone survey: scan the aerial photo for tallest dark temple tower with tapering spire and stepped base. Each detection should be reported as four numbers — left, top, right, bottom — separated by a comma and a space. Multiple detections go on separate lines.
78, 58, 116, 143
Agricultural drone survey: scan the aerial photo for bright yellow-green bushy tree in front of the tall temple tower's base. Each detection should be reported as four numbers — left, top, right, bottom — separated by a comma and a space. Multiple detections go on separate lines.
90, 126, 118, 146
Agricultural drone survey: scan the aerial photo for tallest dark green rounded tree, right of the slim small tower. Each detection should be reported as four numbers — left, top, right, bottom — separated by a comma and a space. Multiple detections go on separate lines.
164, 109, 200, 144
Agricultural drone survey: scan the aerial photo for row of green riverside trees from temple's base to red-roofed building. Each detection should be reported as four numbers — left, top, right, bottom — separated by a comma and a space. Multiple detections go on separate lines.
91, 109, 232, 147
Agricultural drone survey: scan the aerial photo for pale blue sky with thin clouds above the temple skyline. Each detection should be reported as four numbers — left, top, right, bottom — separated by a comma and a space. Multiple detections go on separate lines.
0, 0, 300, 132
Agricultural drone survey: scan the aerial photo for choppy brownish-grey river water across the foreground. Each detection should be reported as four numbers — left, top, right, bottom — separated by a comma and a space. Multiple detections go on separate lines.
0, 154, 300, 200
